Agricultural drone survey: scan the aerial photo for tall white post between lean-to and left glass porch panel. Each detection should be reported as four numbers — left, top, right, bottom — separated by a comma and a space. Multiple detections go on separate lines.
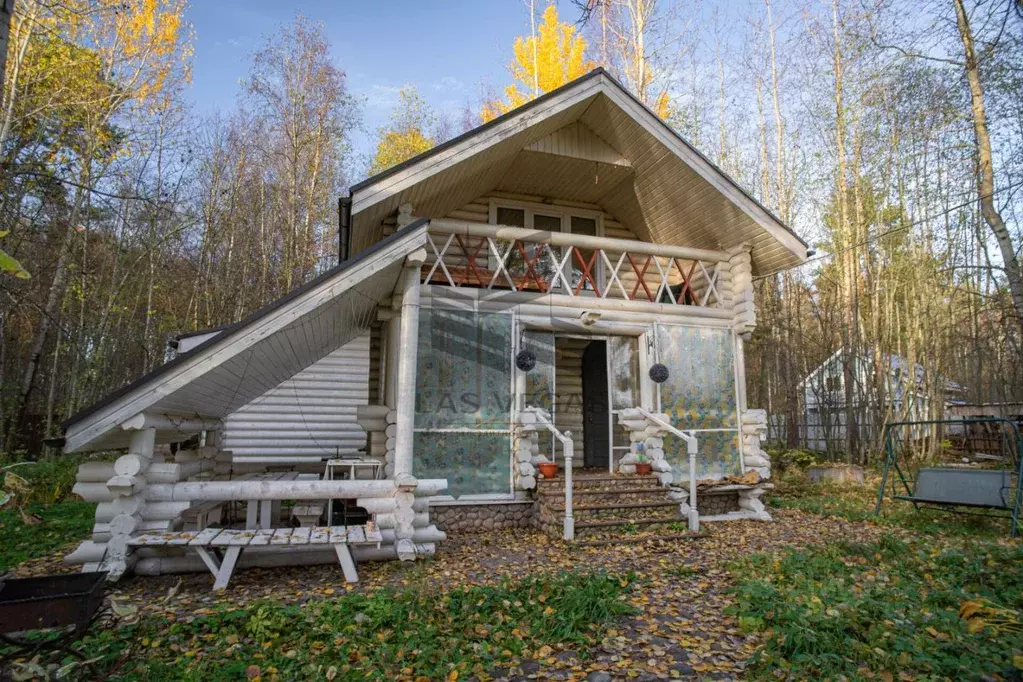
394, 248, 427, 479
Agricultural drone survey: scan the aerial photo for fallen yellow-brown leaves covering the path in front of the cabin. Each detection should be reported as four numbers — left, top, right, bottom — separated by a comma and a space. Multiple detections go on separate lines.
56, 510, 877, 681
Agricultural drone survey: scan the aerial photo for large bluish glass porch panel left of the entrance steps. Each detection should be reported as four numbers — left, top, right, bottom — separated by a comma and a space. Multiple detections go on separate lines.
412, 308, 512, 497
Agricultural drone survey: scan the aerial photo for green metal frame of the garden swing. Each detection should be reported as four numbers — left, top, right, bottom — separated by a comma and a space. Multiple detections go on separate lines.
874, 417, 1023, 538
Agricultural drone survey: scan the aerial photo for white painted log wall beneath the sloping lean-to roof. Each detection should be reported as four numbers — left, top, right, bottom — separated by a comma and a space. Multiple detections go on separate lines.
224, 333, 369, 464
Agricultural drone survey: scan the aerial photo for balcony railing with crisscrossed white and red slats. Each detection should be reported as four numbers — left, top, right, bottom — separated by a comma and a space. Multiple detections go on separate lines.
424, 220, 728, 308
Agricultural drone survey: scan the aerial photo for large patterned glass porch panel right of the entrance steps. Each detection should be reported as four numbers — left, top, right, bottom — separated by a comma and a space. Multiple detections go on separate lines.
657, 325, 741, 480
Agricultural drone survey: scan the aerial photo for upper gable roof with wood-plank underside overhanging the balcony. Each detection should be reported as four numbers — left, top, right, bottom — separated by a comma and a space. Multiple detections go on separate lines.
352, 69, 807, 274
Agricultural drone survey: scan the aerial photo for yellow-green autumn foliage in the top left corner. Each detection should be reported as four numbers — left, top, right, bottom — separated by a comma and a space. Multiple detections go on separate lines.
3, 0, 191, 154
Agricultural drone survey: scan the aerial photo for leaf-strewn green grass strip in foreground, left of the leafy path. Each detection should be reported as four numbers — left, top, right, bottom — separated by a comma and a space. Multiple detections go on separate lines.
56, 573, 633, 680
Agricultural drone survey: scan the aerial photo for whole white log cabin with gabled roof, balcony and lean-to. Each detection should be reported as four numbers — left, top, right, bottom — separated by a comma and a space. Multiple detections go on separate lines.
63, 70, 807, 587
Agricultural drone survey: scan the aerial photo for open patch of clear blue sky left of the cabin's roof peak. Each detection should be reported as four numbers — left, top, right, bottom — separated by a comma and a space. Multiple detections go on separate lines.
186, 0, 560, 163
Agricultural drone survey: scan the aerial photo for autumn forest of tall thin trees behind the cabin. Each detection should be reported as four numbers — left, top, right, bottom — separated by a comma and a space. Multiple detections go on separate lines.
0, 0, 1023, 460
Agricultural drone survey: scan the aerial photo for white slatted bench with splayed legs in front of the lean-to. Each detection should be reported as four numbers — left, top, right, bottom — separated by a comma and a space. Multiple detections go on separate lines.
128, 526, 384, 590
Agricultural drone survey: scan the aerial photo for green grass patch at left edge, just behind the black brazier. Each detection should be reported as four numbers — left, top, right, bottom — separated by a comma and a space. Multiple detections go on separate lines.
0, 502, 96, 574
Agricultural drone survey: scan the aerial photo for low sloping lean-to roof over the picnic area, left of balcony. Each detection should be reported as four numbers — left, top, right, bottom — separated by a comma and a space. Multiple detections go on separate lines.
62, 219, 429, 452
